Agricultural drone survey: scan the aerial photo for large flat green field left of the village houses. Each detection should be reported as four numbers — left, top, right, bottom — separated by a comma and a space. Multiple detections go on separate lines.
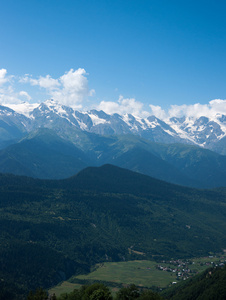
49, 260, 176, 295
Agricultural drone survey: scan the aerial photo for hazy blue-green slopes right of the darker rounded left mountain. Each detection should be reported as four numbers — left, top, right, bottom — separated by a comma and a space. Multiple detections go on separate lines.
77, 135, 226, 188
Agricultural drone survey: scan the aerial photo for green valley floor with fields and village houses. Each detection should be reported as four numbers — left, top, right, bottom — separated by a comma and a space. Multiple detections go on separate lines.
49, 253, 226, 296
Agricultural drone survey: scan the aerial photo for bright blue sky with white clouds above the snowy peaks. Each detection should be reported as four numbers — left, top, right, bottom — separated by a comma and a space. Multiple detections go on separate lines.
0, 0, 226, 116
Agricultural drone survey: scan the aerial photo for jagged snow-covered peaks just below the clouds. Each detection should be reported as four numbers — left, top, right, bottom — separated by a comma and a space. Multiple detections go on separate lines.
0, 99, 226, 154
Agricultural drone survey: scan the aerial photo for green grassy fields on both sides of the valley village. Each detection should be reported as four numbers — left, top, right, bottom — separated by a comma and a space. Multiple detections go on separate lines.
49, 255, 226, 296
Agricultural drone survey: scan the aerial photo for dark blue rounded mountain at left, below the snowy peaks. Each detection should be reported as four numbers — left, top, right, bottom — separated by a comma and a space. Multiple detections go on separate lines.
0, 129, 89, 179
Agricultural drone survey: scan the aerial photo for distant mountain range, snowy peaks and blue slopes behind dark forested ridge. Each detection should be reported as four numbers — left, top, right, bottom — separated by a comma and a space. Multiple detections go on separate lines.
0, 100, 226, 188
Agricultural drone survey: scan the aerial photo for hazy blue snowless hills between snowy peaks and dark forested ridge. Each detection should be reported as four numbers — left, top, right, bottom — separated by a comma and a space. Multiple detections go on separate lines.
0, 128, 226, 188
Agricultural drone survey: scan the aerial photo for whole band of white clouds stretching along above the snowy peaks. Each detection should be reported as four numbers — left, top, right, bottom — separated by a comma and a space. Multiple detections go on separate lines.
0, 68, 226, 121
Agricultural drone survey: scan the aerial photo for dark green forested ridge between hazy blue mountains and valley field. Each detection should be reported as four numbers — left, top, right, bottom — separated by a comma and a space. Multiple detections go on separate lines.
0, 165, 226, 298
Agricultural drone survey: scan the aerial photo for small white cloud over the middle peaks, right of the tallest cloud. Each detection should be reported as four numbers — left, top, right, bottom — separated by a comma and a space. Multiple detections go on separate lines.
97, 96, 150, 117
